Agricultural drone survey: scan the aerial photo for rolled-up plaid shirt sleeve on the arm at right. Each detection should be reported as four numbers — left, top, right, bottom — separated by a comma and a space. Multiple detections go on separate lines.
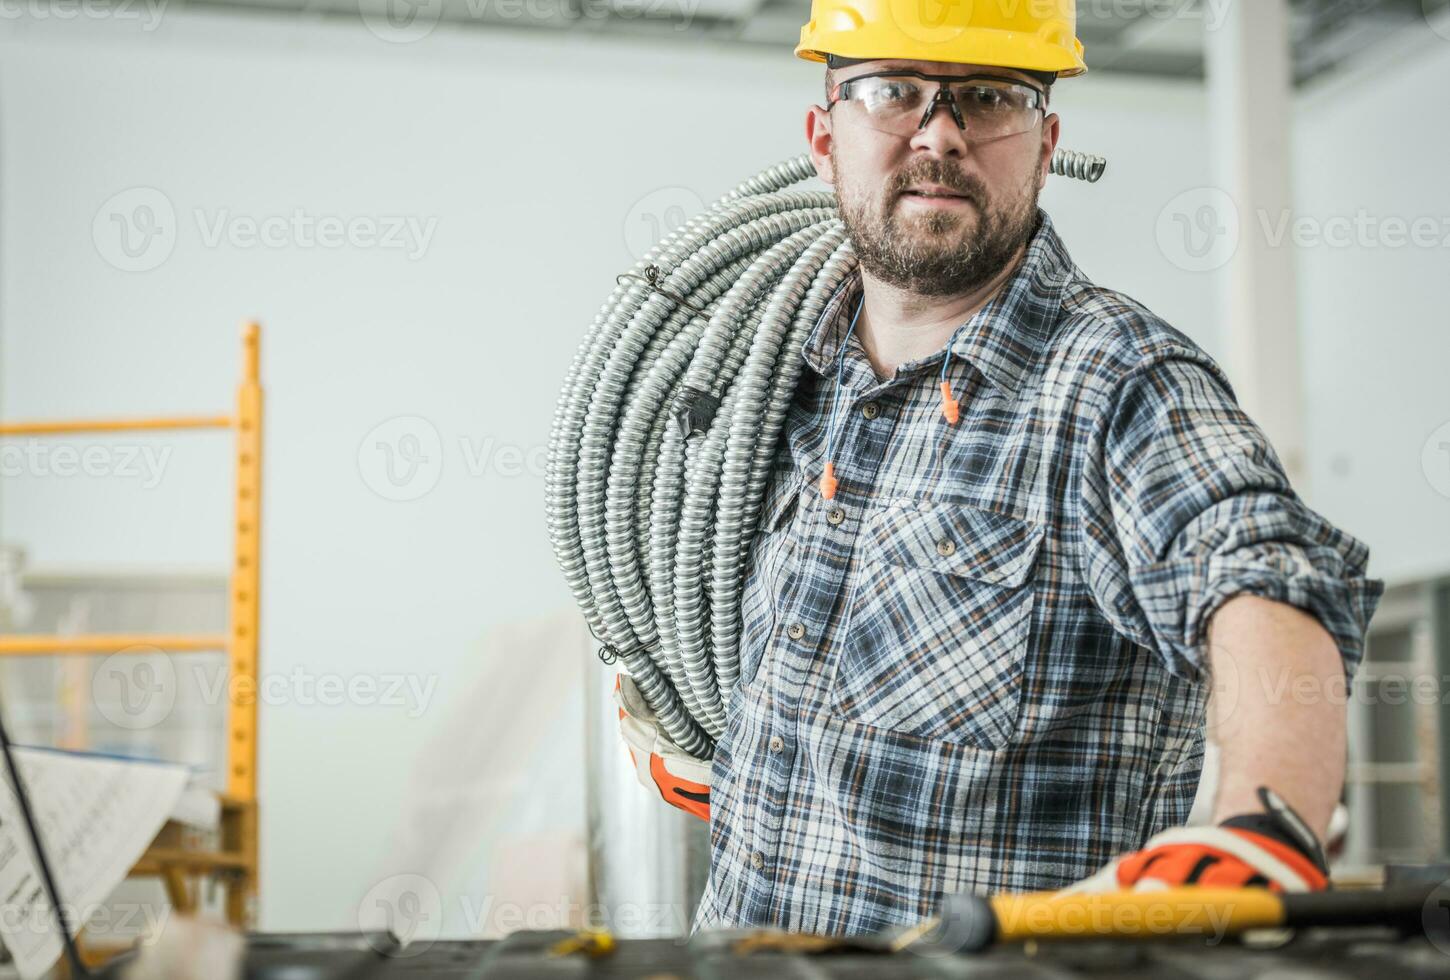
1080, 349, 1385, 678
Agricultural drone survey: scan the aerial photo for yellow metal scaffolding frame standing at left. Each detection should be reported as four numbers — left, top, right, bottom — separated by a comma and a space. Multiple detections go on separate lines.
0, 322, 262, 928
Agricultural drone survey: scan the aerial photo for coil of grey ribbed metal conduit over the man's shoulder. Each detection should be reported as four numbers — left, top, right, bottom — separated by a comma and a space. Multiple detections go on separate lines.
545, 151, 1106, 758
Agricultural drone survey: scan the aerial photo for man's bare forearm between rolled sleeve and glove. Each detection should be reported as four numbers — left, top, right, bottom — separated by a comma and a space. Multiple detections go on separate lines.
1208, 594, 1346, 841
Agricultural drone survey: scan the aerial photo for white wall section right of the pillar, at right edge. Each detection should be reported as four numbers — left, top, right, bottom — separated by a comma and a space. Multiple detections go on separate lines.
1299, 23, 1450, 581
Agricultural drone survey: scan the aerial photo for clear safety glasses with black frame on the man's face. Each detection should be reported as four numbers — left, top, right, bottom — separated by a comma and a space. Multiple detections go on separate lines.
831, 72, 1043, 141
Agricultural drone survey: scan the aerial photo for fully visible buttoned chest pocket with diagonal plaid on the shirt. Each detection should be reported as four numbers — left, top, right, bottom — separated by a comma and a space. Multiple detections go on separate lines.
831, 502, 1043, 748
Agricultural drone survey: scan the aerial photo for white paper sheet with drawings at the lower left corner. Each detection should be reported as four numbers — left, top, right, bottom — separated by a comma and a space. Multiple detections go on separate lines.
0, 748, 187, 980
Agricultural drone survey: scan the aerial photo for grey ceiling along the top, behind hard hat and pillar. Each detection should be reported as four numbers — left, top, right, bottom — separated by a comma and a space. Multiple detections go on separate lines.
178, 0, 1450, 83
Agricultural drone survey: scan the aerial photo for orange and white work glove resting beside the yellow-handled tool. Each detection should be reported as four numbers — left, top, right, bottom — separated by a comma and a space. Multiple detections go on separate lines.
1061, 787, 1330, 894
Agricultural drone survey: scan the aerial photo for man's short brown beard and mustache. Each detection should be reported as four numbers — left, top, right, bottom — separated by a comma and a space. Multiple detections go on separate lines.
831, 146, 1040, 296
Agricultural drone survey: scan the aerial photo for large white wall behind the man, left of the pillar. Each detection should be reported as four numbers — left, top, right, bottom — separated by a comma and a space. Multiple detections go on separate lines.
0, 12, 1215, 932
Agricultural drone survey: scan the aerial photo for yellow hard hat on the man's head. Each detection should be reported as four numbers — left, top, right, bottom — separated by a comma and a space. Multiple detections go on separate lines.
796, 0, 1088, 77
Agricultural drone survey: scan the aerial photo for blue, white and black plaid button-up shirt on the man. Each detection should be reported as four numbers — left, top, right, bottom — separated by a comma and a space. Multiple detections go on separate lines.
696, 213, 1383, 934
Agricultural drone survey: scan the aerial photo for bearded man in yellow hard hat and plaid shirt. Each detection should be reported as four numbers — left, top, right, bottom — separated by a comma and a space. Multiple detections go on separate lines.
614, 0, 1383, 934
